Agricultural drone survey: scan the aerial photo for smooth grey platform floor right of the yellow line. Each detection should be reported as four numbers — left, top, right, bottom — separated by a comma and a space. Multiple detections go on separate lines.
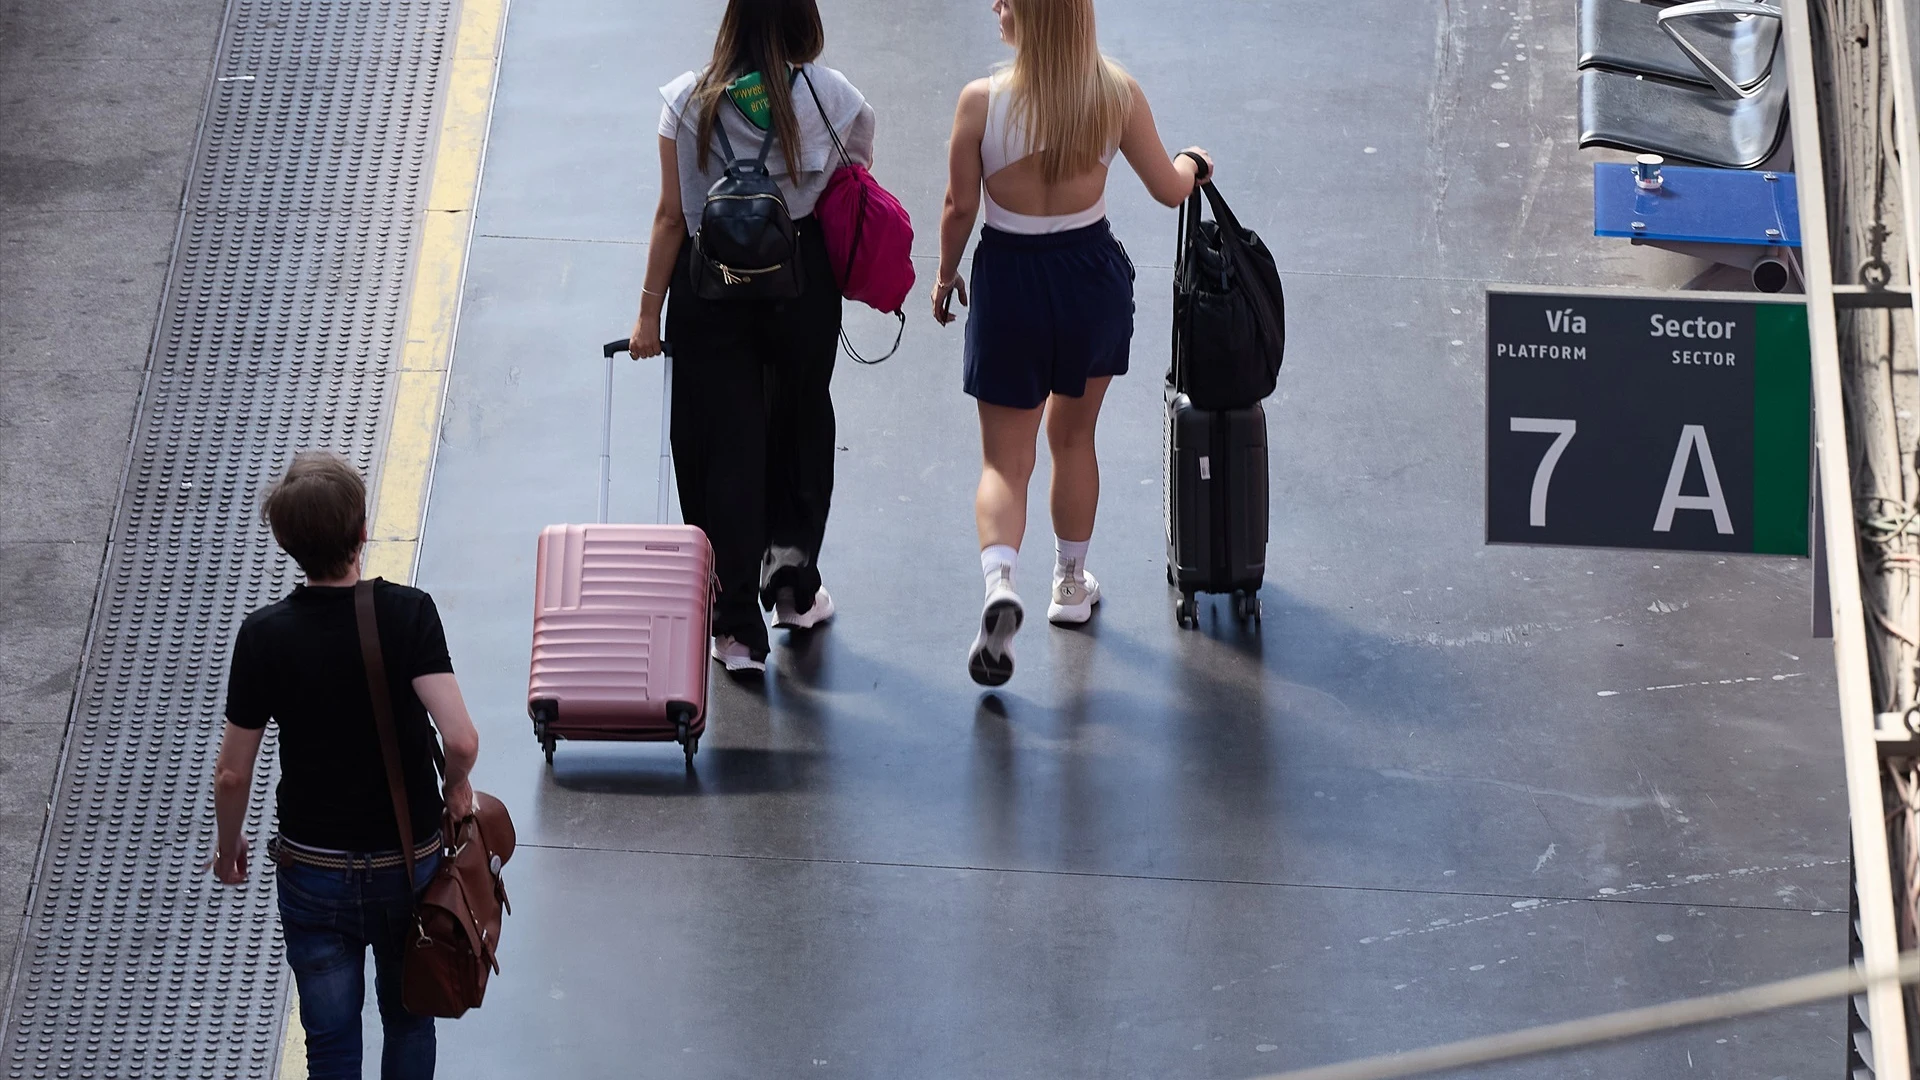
419, 0, 1847, 1080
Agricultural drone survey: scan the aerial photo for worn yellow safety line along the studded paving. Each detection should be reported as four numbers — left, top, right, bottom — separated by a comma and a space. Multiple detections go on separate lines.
280, 0, 507, 1080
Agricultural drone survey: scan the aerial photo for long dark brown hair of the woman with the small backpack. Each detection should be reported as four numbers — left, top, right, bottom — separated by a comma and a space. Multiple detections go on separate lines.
693, 0, 828, 177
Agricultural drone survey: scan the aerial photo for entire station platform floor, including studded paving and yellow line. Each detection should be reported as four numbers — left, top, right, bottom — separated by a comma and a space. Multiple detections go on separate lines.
0, 0, 1847, 1080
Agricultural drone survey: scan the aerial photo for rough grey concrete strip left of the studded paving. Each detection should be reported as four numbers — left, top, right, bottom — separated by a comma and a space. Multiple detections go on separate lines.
0, 0, 225, 983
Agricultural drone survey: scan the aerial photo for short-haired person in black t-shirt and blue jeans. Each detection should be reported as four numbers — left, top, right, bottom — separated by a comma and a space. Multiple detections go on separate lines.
213, 452, 480, 1080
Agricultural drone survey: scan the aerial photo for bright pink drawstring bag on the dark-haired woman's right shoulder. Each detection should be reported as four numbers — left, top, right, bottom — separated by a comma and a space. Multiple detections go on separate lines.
801, 67, 914, 363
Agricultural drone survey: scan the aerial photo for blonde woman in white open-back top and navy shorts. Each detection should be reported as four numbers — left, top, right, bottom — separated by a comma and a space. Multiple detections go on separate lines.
933, 0, 1213, 686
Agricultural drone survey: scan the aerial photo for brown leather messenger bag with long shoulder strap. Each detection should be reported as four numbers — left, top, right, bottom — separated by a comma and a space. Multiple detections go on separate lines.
353, 580, 515, 1019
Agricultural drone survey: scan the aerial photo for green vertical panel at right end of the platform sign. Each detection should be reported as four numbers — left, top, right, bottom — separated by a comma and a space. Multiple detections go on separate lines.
1753, 304, 1812, 555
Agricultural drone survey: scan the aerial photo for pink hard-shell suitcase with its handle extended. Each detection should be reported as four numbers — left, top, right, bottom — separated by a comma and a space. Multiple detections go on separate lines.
526, 340, 714, 767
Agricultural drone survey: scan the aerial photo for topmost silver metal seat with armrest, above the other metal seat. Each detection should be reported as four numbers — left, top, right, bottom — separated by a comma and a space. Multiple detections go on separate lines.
1578, 0, 1780, 90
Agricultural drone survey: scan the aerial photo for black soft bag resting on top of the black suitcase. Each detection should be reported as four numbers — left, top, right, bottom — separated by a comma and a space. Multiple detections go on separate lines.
1167, 183, 1286, 409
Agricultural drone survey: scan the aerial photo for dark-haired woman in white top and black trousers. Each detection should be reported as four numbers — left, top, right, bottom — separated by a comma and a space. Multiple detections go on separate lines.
630, 0, 874, 671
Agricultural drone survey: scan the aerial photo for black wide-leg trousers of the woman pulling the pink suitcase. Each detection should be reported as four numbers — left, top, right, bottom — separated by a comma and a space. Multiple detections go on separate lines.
664, 217, 841, 657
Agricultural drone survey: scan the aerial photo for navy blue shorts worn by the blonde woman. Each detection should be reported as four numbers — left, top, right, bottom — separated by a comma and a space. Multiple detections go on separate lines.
966, 221, 1133, 409
